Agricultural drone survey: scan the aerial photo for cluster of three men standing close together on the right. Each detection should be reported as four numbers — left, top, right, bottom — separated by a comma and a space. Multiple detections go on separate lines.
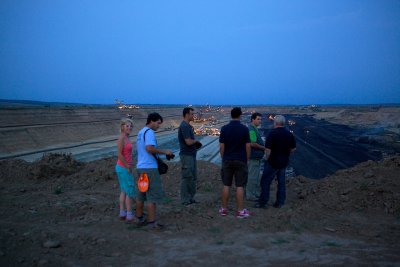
219, 107, 296, 218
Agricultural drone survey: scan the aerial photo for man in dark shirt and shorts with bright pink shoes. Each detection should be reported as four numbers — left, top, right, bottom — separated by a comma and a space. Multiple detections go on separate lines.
219, 107, 251, 218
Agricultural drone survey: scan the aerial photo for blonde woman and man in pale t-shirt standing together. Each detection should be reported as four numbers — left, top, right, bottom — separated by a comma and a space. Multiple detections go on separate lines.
115, 113, 173, 229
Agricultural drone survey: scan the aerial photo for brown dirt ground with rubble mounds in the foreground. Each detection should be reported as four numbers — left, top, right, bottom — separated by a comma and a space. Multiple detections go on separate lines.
0, 154, 400, 266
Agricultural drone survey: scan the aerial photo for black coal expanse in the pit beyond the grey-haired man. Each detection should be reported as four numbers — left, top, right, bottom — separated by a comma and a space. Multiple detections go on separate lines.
263, 115, 400, 179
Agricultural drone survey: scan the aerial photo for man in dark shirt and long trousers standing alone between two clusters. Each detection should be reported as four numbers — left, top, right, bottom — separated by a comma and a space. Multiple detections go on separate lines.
178, 107, 202, 206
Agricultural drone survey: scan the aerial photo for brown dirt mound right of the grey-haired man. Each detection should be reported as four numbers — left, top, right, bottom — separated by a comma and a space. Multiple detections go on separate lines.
292, 157, 400, 216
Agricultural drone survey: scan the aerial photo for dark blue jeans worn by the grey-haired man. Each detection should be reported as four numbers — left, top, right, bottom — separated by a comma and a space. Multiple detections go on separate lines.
259, 161, 286, 206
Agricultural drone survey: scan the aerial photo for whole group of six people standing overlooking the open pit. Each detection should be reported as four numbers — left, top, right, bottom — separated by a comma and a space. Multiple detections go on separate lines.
115, 107, 296, 229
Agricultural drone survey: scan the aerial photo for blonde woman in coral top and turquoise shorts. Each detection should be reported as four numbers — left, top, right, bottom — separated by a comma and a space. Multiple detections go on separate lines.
115, 119, 135, 223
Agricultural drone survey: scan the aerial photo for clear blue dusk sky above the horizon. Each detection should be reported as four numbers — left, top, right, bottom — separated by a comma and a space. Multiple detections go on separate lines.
0, 0, 400, 104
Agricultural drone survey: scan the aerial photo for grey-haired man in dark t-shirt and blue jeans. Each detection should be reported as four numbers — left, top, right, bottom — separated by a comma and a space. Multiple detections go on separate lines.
256, 115, 296, 208
